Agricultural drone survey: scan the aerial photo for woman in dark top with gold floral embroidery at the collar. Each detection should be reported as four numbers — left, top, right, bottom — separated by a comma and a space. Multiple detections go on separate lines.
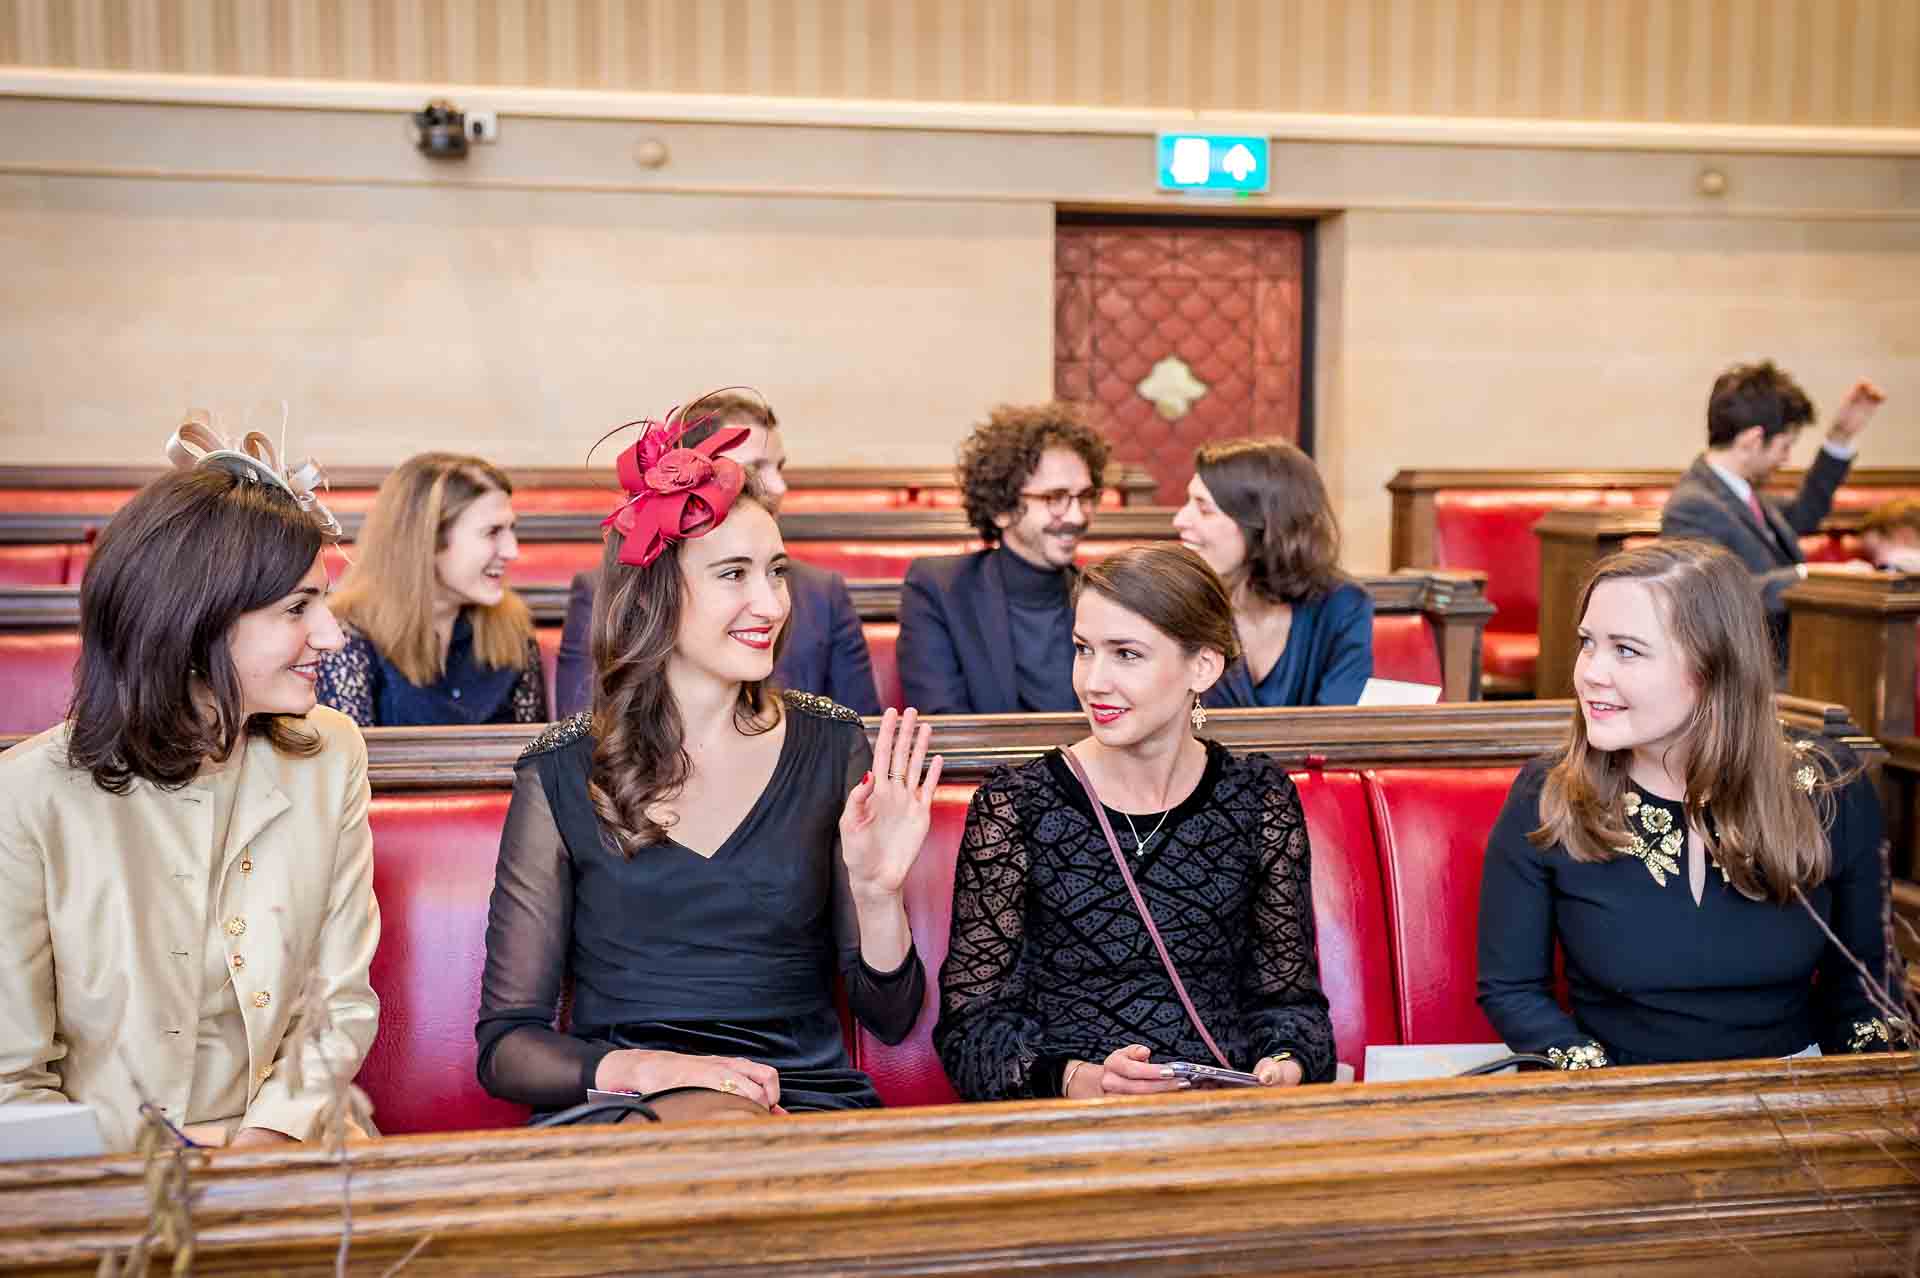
1480, 541, 1901, 1069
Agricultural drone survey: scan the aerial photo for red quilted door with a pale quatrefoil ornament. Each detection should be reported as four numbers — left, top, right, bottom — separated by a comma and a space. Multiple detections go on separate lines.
1054, 219, 1308, 505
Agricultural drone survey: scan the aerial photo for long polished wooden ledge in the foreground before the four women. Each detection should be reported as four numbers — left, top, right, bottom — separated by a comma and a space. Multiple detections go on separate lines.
0, 1053, 1920, 1278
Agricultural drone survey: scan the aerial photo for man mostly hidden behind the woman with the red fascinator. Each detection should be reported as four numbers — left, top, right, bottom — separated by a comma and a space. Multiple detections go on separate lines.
553, 393, 879, 720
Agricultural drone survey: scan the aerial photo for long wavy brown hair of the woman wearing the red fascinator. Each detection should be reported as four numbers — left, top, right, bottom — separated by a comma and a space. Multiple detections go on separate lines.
588, 485, 791, 858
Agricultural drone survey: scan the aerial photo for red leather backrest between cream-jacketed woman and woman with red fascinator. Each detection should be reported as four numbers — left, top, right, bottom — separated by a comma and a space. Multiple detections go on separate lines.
357, 791, 528, 1134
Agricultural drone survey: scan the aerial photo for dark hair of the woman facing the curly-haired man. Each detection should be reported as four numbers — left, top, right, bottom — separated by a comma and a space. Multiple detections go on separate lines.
1194, 439, 1346, 603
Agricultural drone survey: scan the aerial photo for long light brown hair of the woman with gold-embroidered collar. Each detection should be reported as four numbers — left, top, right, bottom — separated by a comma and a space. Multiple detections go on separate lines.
1528, 541, 1845, 904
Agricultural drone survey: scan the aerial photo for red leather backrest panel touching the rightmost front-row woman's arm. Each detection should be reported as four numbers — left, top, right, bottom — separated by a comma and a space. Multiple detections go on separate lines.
1367, 768, 1519, 1044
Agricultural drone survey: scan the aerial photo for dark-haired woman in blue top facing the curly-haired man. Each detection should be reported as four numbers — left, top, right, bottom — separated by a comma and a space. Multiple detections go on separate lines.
1173, 439, 1373, 706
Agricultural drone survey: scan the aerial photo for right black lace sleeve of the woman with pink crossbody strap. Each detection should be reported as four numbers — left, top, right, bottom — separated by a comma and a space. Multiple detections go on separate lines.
1240, 756, 1334, 1082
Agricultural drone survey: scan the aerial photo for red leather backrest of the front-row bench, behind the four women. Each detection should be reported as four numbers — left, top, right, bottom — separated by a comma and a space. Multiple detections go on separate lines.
359, 768, 1515, 1134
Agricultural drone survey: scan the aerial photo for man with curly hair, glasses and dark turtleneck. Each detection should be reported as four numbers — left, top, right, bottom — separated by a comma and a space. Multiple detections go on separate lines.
899, 403, 1108, 714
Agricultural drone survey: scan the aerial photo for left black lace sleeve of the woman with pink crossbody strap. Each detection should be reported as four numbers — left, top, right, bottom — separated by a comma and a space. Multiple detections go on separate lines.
933, 769, 1058, 1100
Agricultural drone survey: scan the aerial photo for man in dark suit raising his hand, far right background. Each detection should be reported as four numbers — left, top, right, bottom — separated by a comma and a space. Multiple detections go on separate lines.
1661, 363, 1882, 670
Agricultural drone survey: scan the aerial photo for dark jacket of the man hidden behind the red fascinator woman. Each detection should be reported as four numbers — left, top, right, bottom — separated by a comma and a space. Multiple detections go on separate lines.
553, 560, 879, 720
